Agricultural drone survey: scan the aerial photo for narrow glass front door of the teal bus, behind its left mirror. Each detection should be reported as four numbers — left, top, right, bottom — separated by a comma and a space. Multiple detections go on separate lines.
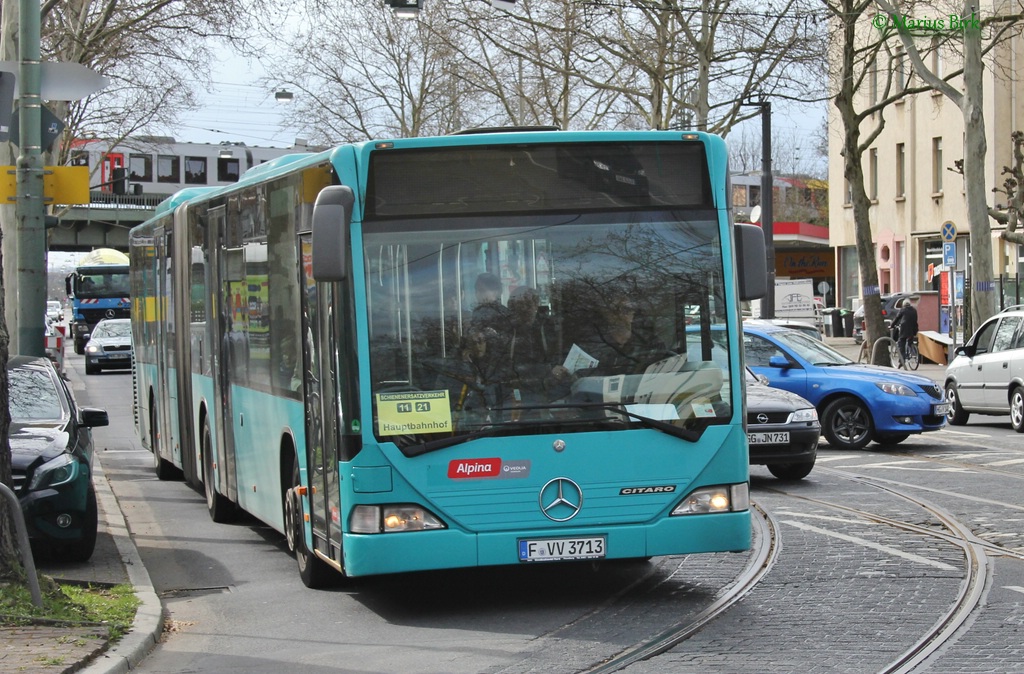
300, 234, 343, 566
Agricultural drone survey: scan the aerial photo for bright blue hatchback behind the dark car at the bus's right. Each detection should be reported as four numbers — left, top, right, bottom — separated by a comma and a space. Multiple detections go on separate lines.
743, 325, 949, 450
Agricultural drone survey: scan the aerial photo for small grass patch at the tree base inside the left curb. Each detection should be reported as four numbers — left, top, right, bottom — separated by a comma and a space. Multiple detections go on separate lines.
0, 576, 139, 640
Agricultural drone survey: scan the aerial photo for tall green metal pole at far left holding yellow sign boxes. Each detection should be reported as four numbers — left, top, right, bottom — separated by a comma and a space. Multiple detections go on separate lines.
10, 0, 46, 355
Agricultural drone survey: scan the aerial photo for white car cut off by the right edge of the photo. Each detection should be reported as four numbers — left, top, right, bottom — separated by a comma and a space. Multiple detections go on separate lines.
945, 306, 1024, 433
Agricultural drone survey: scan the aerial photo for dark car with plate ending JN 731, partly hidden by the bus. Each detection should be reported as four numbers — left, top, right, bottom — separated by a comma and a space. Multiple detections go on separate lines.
746, 369, 821, 479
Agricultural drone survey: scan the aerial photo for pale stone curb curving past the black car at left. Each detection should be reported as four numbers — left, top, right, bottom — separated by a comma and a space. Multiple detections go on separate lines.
79, 452, 164, 674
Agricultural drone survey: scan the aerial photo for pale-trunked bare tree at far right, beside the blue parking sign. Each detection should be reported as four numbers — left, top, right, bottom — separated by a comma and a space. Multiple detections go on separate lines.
876, 0, 1024, 326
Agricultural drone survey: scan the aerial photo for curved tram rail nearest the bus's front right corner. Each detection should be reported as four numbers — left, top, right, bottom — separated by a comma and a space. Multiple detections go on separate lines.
579, 504, 782, 674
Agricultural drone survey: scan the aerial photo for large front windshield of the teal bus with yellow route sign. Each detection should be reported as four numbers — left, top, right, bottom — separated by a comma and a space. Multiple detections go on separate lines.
364, 209, 732, 453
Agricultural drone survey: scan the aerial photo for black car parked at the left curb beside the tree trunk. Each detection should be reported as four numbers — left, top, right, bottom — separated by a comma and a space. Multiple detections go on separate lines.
7, 355, 110, 561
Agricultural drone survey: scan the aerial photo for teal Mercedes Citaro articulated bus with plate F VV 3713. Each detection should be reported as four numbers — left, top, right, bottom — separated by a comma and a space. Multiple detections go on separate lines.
130, 129, 766, 587
